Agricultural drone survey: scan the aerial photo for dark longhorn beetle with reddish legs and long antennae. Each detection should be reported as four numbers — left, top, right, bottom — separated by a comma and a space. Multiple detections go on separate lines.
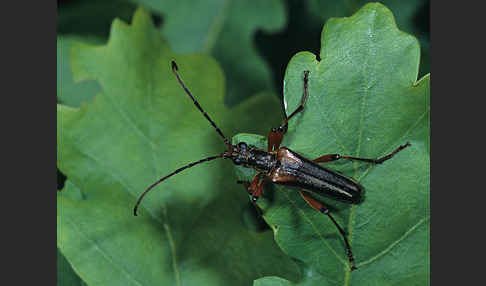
133, 61, 410, 270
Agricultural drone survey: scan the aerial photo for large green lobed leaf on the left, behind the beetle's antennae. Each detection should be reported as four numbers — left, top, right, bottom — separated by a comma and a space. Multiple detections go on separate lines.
57, 10, 299, 285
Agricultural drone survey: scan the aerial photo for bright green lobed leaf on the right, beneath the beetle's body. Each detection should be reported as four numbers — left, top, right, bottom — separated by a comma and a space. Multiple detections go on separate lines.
233, 4, 430, 285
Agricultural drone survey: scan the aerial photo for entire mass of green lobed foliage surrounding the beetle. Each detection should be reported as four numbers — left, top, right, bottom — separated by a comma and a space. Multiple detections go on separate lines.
57, 0, 430, 286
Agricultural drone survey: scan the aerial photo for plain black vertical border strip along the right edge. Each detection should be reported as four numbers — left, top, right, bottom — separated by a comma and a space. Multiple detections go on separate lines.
431, 1, 486, 285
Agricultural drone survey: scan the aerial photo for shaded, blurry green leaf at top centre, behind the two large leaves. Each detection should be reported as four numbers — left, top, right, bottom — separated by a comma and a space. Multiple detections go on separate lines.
127, 0, 286, 106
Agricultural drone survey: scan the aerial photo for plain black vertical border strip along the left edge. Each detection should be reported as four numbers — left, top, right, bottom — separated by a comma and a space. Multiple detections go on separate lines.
1, 1, 57, 285
